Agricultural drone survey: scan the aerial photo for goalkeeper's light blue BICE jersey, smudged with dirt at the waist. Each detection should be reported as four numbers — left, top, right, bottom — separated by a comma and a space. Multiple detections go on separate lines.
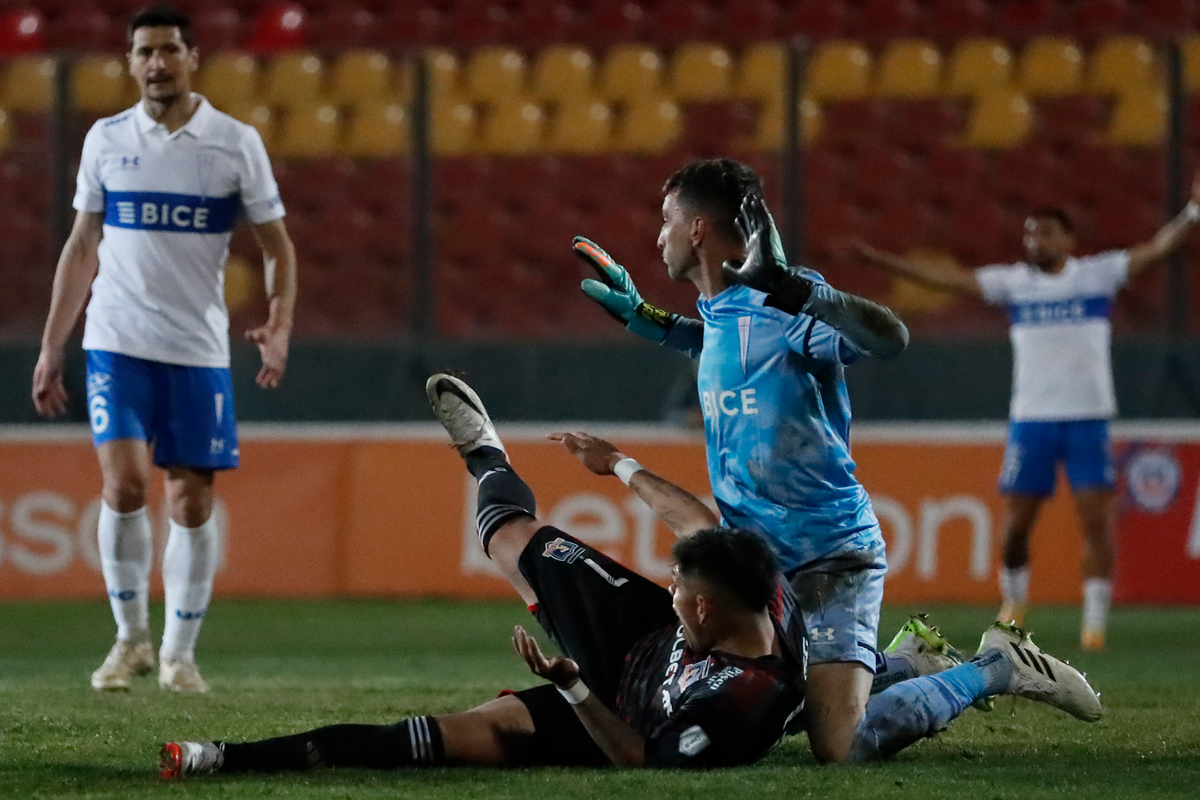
697, 270, 882, 573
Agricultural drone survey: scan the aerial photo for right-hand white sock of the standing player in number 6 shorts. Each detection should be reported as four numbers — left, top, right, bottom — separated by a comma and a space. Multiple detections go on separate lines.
158, 517, 217, 661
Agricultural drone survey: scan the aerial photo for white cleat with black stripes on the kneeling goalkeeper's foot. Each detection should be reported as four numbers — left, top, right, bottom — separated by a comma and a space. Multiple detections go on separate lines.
976, 622, 1102, 722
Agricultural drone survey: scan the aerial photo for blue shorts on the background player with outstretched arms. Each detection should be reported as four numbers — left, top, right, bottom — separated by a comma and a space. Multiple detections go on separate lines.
1000, 420, 1116, 497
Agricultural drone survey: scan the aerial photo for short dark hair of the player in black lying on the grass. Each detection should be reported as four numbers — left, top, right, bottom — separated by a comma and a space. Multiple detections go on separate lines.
671, 527, 779, 612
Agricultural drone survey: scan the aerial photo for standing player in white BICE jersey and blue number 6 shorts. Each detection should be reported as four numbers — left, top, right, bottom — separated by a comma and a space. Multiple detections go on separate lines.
34, 6, 296, 692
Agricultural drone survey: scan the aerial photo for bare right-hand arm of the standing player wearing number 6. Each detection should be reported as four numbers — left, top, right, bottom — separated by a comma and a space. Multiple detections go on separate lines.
246, 219, 296, 389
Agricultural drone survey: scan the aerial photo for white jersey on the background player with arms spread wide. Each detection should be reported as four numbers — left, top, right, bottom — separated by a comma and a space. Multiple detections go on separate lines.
976, 251, 1129, 421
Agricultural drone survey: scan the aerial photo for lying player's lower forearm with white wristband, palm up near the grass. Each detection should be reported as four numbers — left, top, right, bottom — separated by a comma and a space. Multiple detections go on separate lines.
512, 625, 646, 766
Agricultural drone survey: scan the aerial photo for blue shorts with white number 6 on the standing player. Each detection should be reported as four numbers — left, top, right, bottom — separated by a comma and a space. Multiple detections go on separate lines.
88, 350, 238, 469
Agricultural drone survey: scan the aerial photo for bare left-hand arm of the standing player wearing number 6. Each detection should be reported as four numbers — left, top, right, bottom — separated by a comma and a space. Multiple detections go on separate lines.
34, 211, 104, 419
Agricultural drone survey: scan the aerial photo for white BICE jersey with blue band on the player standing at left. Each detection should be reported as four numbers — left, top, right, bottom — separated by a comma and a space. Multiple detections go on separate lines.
73, 95, 283, 367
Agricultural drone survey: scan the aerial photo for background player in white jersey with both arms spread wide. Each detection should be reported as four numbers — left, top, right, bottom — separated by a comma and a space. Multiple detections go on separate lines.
850, 180, 1200, 650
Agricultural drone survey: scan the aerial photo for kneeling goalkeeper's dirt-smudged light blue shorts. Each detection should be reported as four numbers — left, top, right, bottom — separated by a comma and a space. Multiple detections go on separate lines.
788, 545, 888, 672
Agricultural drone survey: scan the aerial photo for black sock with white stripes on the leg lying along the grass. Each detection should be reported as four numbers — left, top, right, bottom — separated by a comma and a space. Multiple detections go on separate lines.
221, 716, 445, 772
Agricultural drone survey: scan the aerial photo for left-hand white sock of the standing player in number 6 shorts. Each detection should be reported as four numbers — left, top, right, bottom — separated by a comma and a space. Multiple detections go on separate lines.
96, 500, 154, 639
